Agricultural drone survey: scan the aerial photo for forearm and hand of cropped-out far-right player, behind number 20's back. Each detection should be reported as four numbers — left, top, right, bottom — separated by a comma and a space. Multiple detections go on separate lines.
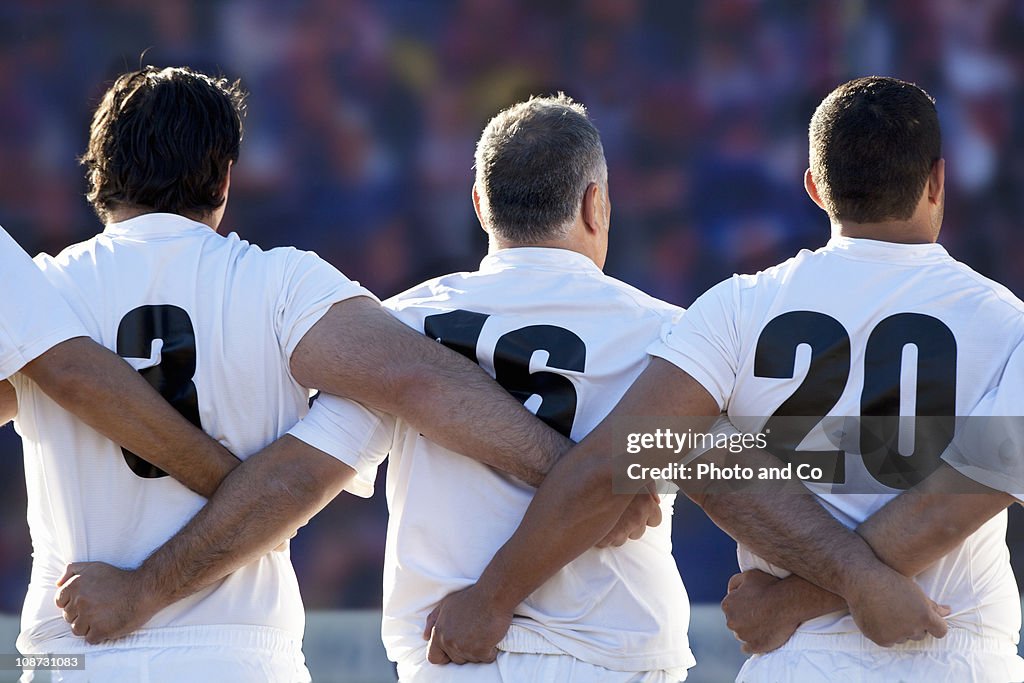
722, 463, 1014, 652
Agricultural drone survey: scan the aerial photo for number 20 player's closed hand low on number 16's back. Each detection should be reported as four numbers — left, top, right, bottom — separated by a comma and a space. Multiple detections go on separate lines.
423, 586, 512, 664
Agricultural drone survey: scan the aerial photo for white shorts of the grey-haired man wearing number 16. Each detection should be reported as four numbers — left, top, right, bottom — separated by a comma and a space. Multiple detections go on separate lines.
398, 651, 686, 683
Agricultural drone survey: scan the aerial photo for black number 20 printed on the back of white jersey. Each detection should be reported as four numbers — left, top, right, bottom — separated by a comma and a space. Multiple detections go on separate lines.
754, 310, 956, 489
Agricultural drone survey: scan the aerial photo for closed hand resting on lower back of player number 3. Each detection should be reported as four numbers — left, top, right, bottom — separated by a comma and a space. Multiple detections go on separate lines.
56, 562, 160, 644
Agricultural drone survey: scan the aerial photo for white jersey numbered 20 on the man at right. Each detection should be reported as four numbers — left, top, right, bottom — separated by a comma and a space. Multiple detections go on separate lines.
651, 238, 1024, 642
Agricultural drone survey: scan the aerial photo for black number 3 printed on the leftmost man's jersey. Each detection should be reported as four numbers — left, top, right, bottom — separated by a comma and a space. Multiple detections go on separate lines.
117, 305, 203, 479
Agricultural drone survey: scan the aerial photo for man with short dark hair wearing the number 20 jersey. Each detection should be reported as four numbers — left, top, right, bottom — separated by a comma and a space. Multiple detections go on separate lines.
435, 78, 1024, 683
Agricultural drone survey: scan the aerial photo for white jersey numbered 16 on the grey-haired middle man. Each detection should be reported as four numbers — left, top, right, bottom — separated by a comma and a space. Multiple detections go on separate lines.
291, 248, 694, 678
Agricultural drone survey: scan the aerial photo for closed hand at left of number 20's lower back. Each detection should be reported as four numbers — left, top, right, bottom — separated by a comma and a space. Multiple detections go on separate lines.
722, 569, 801, 654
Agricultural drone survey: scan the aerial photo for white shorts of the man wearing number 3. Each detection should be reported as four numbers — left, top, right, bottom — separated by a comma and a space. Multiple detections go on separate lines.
20, 627, 310, 683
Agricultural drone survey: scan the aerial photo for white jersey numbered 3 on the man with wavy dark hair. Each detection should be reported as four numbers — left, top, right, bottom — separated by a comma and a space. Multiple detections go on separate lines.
14, 214, 370, 652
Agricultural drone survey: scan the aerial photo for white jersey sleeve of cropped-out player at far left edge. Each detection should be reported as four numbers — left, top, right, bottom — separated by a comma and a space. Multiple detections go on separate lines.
0, 227, 86, 381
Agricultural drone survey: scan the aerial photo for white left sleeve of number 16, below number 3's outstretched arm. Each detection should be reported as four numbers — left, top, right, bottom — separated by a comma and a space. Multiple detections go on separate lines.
288, 393, 395, 498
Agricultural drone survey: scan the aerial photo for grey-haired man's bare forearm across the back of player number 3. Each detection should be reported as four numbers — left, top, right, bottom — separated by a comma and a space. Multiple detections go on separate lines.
137, 436, 354, 609
